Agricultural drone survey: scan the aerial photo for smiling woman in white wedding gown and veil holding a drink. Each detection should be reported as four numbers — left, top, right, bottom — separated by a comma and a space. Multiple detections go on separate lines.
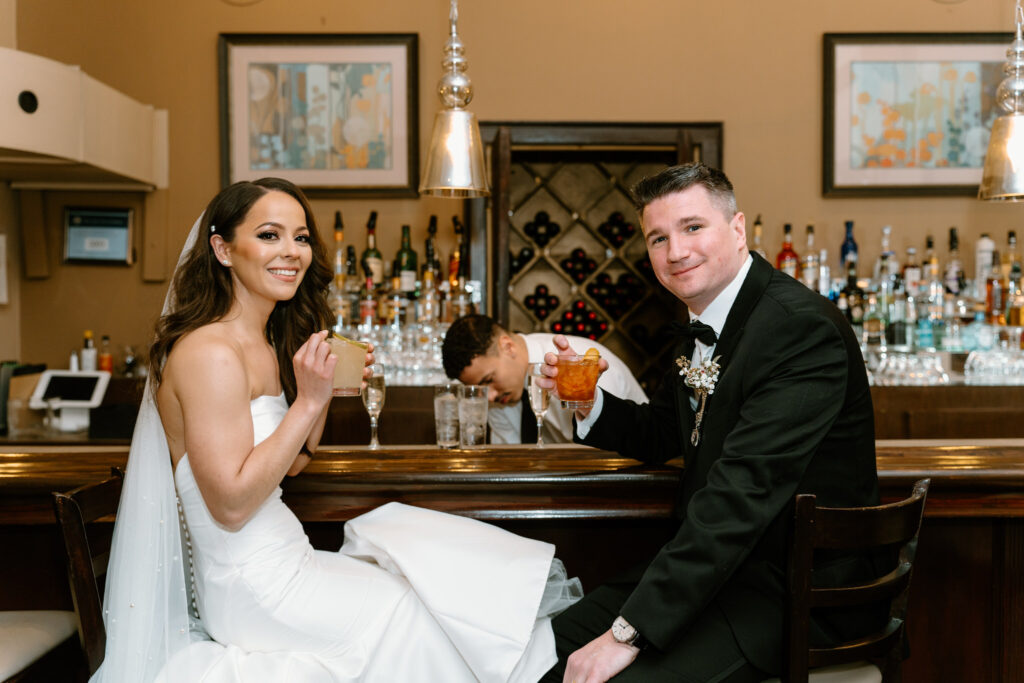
93, 178, 580, 683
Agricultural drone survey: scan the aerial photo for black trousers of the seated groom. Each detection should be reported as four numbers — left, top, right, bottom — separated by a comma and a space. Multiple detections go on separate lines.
541, 582, 769, 683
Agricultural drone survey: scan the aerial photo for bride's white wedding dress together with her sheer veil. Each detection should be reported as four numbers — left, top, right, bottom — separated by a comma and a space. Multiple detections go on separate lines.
90, 209, 582, 683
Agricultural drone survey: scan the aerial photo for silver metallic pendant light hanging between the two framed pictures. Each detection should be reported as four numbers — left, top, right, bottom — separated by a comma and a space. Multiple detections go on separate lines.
420, 0, 490, 198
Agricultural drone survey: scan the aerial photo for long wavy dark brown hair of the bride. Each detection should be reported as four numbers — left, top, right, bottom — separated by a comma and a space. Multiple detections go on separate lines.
150, 178, 332, 403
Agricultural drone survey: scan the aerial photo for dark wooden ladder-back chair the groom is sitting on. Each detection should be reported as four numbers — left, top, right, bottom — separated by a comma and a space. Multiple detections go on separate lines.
781, 479, 931, 683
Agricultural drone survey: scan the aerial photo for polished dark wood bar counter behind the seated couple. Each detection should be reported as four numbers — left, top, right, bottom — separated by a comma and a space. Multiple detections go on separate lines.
0, 439, 1024, 683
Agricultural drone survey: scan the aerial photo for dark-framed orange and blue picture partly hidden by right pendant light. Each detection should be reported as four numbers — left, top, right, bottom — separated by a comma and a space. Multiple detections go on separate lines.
822, 33, 1013, 197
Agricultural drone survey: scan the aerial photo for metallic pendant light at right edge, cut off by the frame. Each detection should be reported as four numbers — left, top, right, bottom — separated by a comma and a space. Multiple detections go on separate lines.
978, 0, 1024, 202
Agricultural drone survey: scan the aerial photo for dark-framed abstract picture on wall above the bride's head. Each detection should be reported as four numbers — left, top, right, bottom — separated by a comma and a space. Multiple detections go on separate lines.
218, 34, 420, 197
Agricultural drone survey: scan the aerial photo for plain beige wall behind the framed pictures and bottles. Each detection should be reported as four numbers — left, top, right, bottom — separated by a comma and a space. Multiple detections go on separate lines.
9, 0, 1024, 364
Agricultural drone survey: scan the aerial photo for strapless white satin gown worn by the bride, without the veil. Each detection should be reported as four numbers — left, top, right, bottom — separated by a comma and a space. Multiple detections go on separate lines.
161, 395, 581, 683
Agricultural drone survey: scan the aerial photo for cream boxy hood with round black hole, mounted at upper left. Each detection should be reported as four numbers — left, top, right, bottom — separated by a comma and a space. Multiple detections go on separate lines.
0, 47, 168, 190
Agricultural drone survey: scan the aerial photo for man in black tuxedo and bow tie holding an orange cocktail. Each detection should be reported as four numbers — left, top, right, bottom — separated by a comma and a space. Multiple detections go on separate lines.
544, 164, 884, 683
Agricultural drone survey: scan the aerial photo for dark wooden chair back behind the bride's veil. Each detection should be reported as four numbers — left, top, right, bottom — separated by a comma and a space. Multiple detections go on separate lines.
53, 467, 124, 676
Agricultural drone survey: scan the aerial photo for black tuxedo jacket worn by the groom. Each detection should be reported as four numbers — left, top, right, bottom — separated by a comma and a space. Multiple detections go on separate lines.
584, 254, 879, 671
